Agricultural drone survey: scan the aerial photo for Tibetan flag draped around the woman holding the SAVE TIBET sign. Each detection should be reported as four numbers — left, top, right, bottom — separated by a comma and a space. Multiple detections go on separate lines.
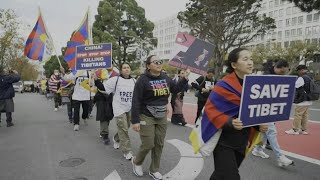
189, 73, 261, 155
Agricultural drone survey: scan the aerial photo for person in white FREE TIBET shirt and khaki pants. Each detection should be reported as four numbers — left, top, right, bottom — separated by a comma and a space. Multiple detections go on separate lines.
104, 63, 136, 160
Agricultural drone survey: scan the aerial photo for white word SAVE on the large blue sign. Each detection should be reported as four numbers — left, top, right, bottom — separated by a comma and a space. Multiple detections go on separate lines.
250, 84, 289, 99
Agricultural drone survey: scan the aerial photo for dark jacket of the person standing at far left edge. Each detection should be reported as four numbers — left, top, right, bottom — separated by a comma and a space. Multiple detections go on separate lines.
0, 74, 20, 100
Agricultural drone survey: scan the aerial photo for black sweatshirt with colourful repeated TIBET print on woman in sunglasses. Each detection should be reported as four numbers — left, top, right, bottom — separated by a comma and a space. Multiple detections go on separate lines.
131, 72, 188, 124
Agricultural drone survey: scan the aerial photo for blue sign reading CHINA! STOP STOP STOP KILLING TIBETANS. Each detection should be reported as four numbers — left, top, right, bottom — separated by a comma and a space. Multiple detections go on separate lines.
76, 44, 112, 70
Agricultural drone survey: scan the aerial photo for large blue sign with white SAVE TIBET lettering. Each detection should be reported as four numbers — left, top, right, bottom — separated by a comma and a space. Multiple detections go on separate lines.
239, 75, 297, 127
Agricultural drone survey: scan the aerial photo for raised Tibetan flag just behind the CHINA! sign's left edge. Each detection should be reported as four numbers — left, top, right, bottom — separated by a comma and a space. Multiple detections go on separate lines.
64, 11, 89, 72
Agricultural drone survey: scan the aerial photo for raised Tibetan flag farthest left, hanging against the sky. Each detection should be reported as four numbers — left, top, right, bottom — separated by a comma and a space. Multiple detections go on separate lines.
24, 9, 53, 62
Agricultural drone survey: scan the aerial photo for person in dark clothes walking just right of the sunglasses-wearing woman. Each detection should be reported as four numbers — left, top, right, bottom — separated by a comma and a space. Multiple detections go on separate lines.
171, 70, 189, 126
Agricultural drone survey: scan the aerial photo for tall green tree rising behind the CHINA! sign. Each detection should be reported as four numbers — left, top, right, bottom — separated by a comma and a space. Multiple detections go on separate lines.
92, 0, 156, 64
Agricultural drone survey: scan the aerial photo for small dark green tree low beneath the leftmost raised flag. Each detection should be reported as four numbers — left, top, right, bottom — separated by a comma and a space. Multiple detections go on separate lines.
43, 55, 69, 77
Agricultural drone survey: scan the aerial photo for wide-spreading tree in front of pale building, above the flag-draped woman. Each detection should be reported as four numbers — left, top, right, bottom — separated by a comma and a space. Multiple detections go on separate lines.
178, 0, 275, 74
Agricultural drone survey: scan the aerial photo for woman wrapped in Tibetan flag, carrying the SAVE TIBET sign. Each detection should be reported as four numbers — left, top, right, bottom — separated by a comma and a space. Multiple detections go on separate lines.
205, 48, 268, 180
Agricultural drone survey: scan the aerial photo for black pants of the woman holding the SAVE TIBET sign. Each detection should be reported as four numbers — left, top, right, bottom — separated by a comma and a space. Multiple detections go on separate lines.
210, 144, 244, 180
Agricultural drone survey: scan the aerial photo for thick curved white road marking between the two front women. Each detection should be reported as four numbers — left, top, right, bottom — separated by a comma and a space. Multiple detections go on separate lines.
163, 139, 204, 180
